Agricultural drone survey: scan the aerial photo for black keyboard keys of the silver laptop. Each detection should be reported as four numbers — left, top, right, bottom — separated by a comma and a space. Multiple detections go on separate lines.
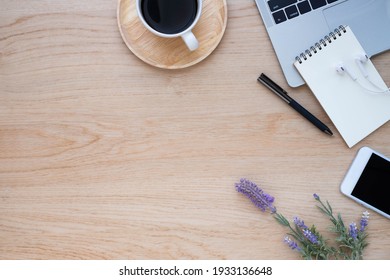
268, 0, 338, 24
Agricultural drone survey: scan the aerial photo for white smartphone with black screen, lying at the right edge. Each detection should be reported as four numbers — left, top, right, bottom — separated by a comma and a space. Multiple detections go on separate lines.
340, 147, 390, 219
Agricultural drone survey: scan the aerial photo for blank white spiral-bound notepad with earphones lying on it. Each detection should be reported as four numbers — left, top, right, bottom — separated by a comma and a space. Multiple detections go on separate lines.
294, 26, 390, 147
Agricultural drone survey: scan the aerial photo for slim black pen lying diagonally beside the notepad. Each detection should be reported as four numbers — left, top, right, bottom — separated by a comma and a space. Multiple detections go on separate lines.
257, 73, 333, 135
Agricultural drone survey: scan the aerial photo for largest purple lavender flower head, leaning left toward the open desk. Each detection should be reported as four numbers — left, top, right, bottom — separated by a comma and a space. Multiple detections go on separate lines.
235, 179, 276, 213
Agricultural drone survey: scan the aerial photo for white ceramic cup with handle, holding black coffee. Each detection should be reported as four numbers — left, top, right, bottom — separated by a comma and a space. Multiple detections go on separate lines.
137, 0, 202, 51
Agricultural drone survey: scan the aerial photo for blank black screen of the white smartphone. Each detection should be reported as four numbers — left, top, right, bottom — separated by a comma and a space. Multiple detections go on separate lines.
351, 154, 390, 215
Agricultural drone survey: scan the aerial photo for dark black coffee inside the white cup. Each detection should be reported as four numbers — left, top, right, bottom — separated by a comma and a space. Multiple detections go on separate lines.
141, 0, 198, 34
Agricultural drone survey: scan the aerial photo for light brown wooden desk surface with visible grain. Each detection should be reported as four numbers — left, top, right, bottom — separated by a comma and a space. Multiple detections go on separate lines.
0, 0, 390, 259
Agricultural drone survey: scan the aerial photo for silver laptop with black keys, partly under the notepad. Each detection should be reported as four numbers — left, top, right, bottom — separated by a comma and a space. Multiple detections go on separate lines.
255, 0, 390, 87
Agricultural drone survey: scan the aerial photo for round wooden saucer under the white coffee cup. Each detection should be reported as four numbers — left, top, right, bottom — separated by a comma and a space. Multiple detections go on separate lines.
117, 0, 227, 69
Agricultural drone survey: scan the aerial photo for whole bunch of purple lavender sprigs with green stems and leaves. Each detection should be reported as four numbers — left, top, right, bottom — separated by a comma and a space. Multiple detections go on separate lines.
235, 179, 369, 260
